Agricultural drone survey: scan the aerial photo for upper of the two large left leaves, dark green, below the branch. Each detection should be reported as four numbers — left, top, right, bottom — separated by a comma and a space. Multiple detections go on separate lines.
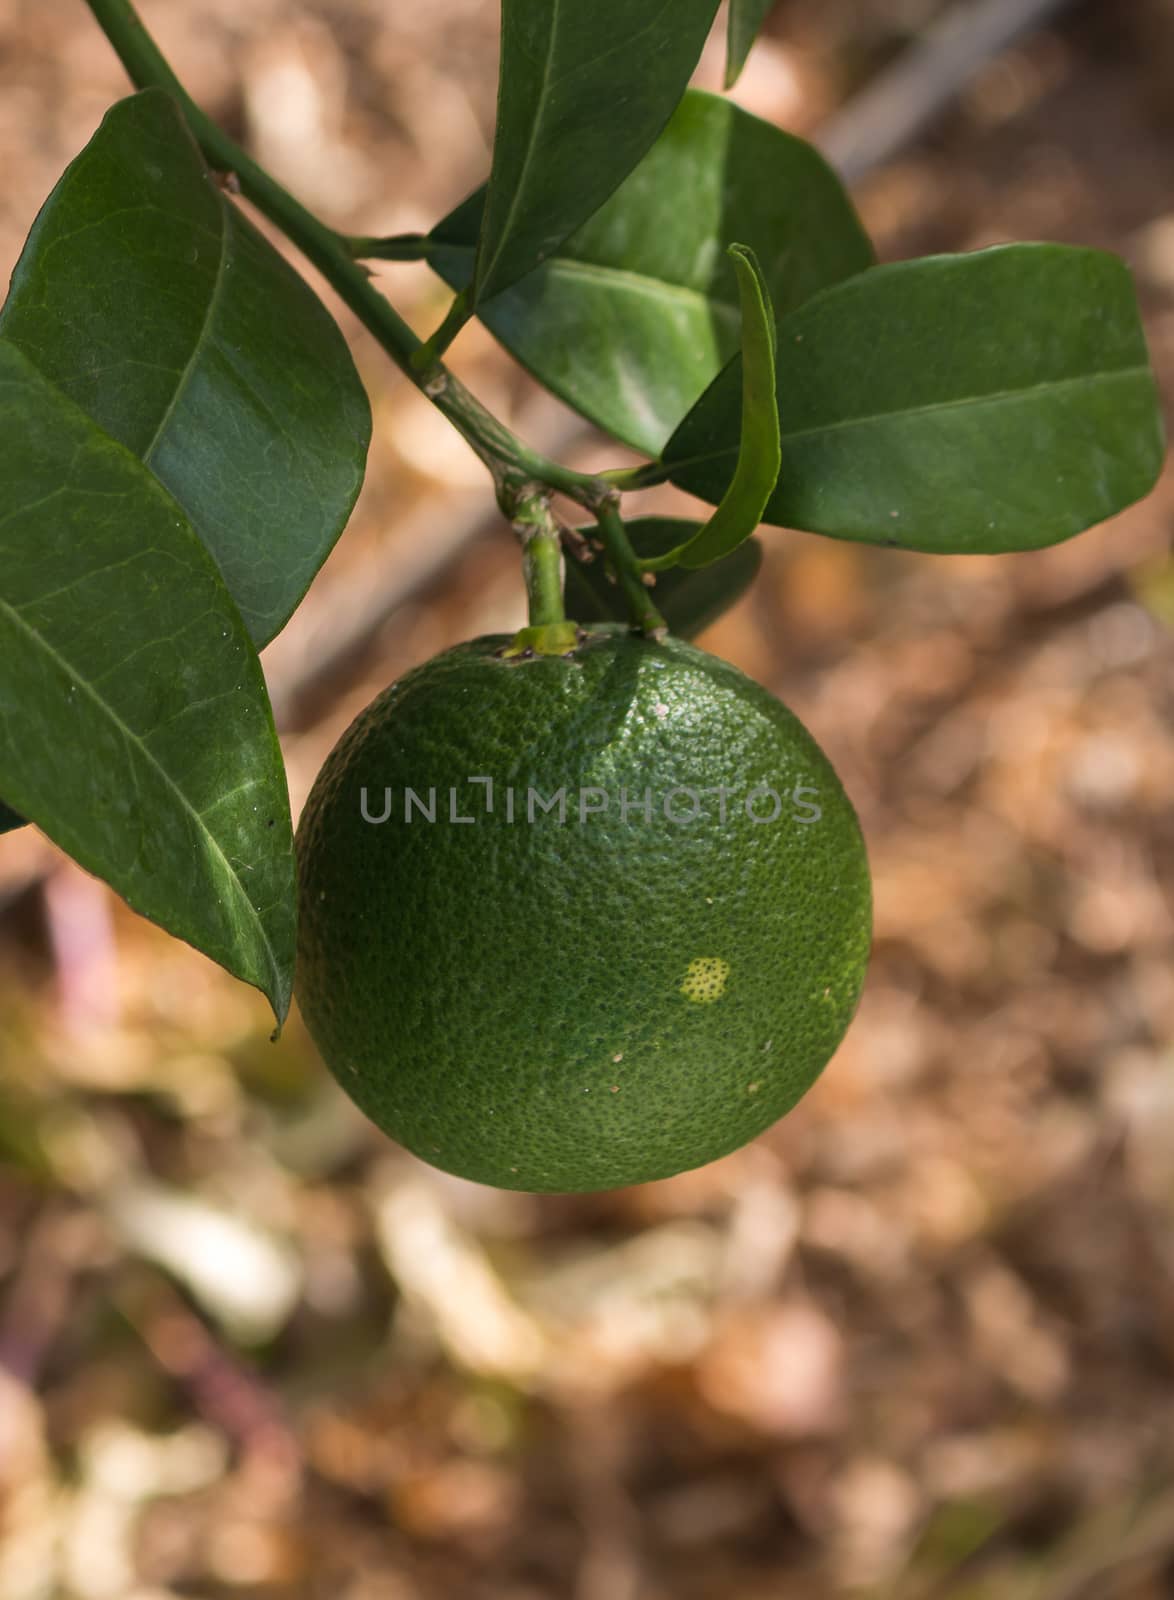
0, 90, 371, 645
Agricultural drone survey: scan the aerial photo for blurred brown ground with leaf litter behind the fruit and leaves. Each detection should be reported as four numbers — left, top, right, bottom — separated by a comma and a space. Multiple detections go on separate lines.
0, 0, 1174, 1600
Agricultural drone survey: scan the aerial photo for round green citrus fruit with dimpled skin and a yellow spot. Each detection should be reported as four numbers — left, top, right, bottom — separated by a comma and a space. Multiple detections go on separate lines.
297, 624, 872, 1192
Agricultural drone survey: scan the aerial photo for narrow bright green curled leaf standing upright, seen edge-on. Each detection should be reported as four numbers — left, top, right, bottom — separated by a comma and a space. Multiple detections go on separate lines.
657, 245, 781, 566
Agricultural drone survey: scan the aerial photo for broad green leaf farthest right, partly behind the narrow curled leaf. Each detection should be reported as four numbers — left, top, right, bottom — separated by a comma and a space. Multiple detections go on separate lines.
664, 245, 1163, 552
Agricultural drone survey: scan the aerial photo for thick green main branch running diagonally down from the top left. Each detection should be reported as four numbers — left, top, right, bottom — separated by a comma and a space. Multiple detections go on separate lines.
86, 0, 608, 509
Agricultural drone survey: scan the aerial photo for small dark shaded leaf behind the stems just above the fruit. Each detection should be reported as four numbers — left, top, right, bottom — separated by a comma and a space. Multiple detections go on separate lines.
563, 517, 763, 638
